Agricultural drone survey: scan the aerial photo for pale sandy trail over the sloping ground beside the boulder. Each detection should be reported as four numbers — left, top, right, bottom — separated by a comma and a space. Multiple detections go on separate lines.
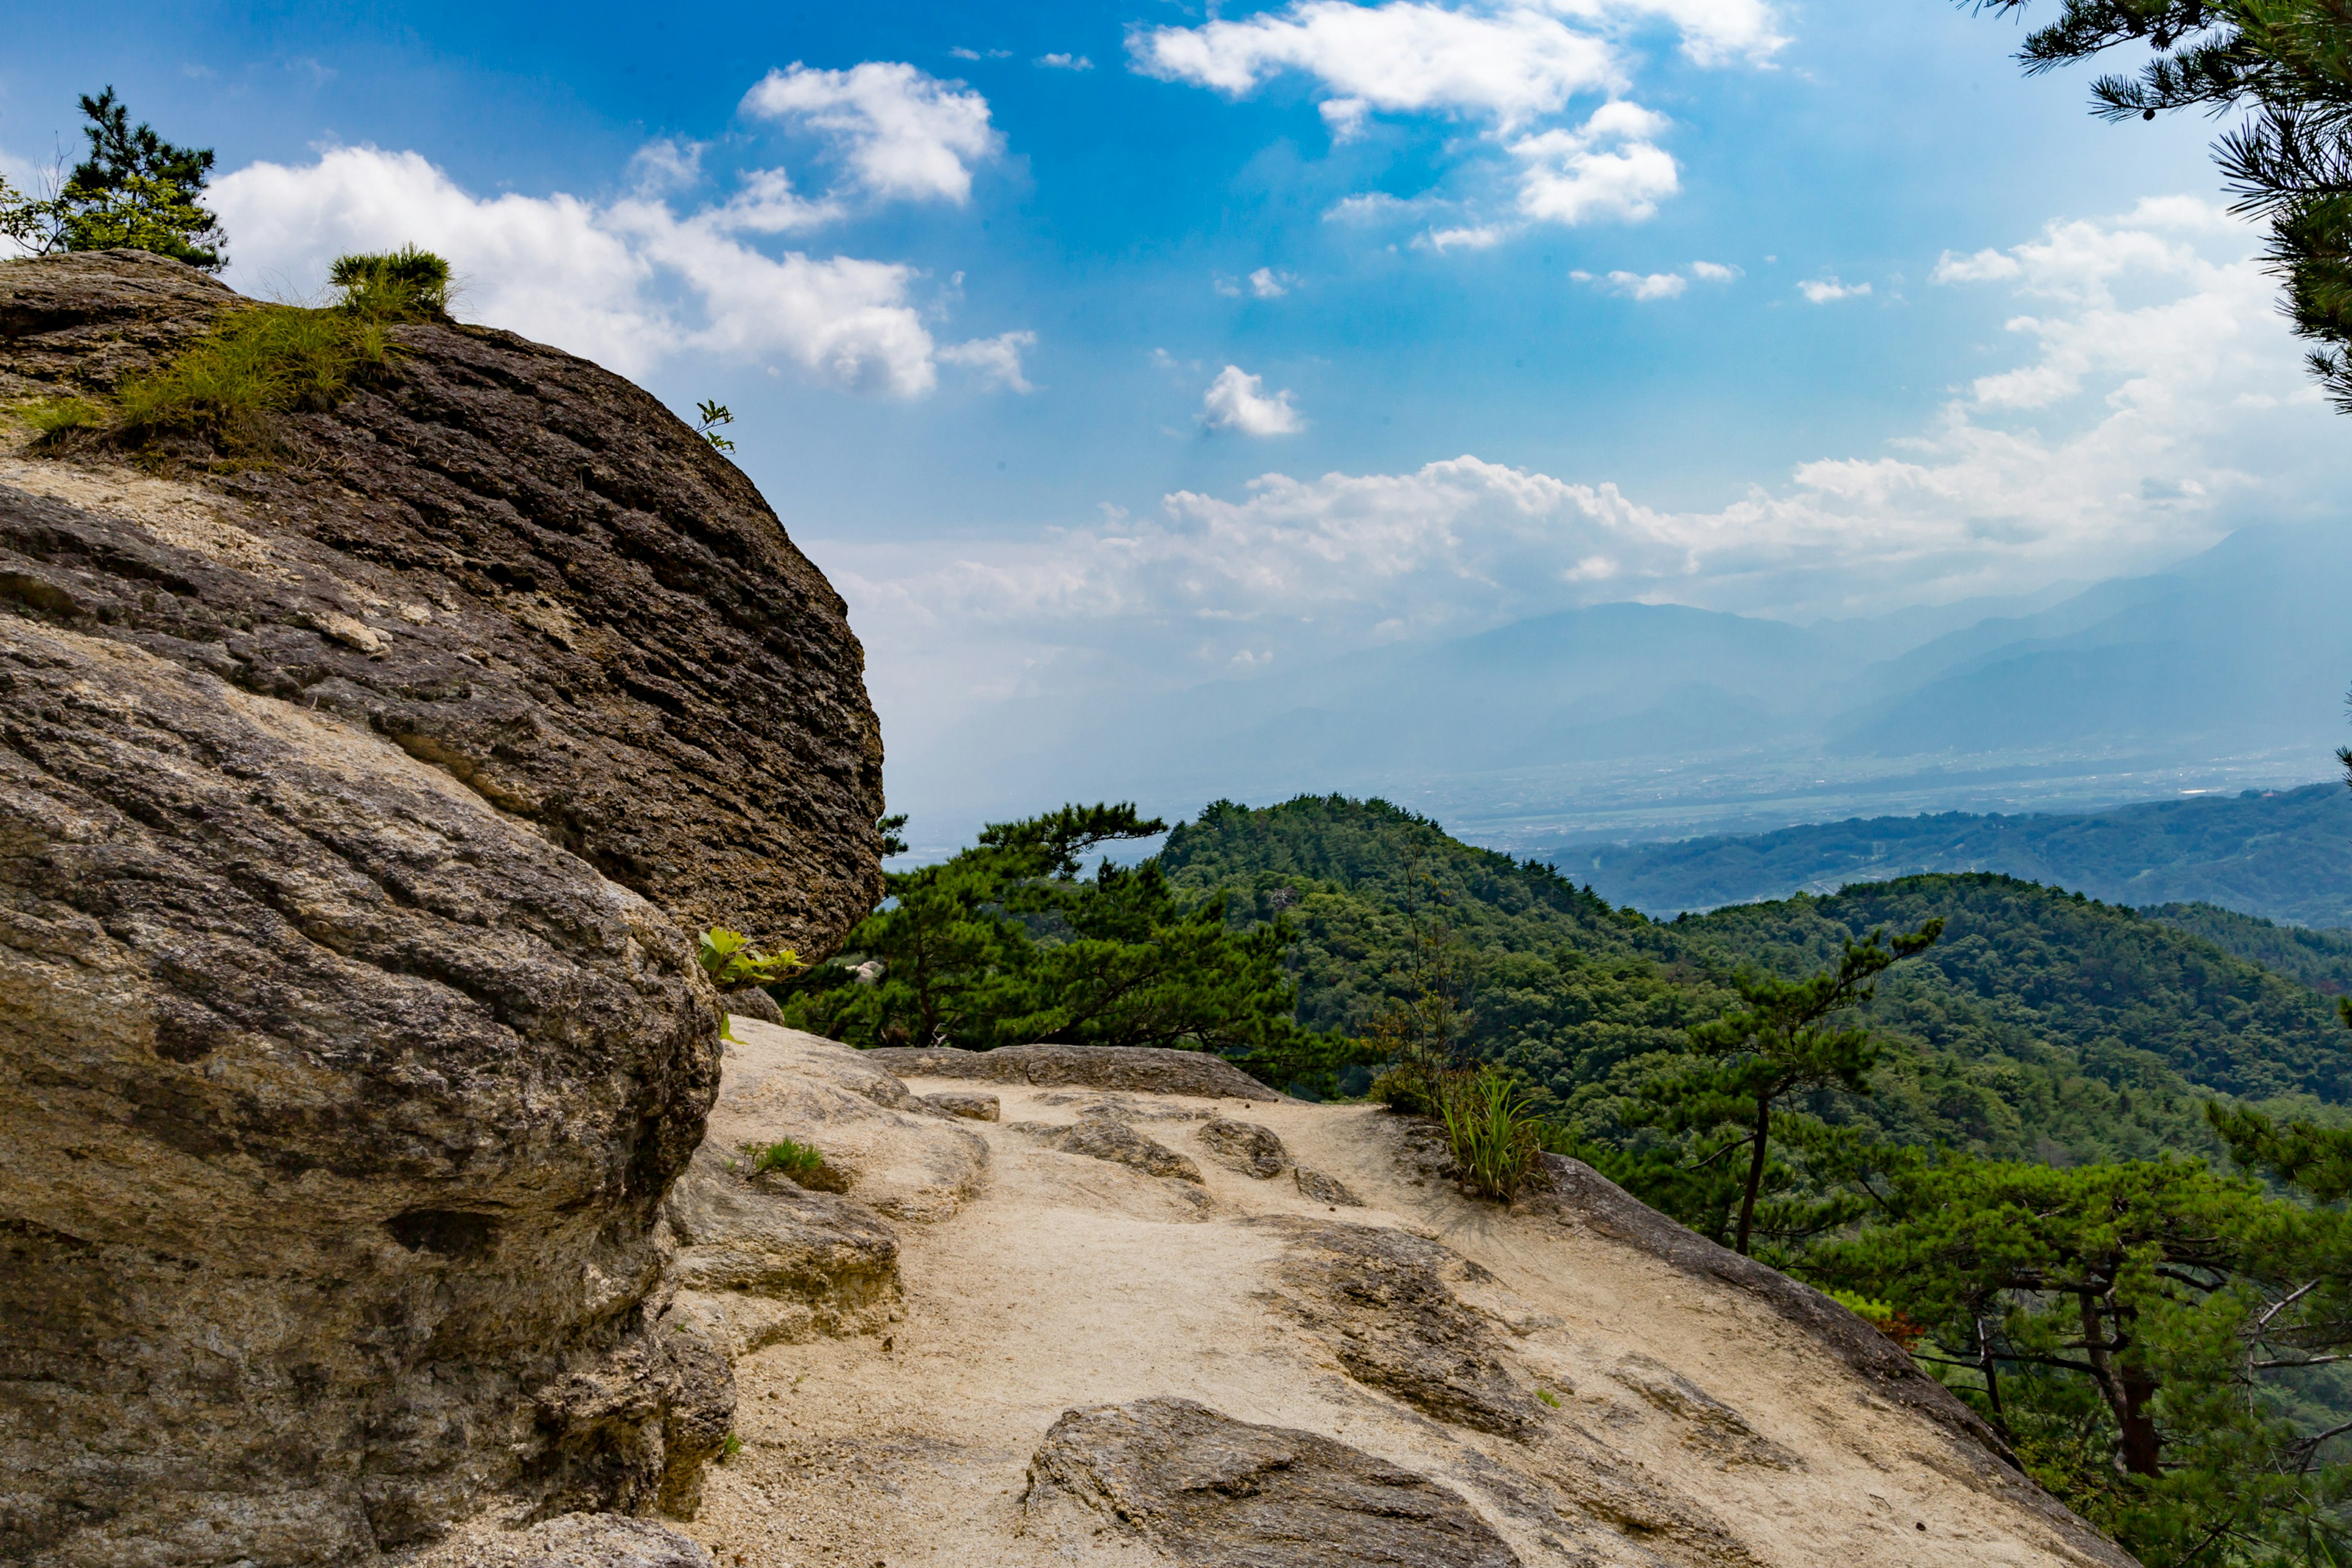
687, 1023, 2126, 1568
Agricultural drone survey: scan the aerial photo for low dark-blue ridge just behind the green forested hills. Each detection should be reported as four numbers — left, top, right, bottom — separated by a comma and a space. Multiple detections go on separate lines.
1534, 783, 2352, 926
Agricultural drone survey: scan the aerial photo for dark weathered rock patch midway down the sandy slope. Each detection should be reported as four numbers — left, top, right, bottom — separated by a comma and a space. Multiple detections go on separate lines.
1261, 1218, 1543, 1439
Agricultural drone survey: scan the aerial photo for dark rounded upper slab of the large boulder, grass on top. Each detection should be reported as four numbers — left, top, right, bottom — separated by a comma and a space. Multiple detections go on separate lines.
0, 252, 882, 957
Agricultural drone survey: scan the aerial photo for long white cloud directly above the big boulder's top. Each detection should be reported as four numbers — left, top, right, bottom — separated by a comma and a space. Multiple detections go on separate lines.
209, 148, 936, 395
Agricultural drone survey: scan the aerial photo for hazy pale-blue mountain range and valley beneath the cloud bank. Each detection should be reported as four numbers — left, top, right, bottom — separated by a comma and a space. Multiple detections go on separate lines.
891, 524, 2352, 851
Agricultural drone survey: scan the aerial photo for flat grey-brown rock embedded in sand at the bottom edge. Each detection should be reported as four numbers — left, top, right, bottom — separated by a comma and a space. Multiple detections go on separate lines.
1023, 1399, 1520, 1568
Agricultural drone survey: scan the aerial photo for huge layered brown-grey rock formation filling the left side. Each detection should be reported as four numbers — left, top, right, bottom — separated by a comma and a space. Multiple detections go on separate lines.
0, 254, 882, 1568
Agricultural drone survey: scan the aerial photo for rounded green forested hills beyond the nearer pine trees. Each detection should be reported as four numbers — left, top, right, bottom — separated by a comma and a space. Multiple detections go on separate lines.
1162, 797, 2352, 1164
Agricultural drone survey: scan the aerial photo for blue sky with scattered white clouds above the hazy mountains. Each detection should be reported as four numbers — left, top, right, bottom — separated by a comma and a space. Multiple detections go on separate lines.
0, 0, 2347, 827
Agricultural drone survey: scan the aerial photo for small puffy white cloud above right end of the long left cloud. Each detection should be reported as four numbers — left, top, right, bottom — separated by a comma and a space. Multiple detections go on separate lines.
743, 61, 1005, 205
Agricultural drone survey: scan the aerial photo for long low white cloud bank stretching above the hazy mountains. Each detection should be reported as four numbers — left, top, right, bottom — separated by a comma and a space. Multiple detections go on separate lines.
821, 205, 2352, 719
